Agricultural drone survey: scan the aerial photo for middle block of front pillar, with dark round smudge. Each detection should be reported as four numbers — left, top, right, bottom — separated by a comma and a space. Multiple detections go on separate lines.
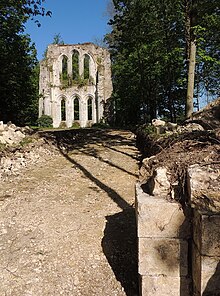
139, 238, 188, 277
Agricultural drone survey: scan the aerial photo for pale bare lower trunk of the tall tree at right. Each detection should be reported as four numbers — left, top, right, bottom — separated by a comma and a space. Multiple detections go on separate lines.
186, 40, 196, 118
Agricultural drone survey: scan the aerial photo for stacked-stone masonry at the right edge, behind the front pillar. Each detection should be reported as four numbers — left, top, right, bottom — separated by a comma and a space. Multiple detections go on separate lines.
188, 164, 220, 296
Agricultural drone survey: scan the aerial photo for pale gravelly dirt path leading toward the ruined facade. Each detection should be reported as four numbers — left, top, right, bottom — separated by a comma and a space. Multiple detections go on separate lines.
0, 130, 138, 296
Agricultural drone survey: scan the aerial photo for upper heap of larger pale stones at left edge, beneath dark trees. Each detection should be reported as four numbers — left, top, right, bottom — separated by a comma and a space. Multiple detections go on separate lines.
0, 121, 33, 145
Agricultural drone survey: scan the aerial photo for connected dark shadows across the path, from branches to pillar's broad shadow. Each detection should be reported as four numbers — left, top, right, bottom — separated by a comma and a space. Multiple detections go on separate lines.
41, 129, 138, 296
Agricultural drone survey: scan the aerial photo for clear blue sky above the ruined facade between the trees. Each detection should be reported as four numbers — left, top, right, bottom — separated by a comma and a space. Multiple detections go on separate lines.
26, 0, 109, 60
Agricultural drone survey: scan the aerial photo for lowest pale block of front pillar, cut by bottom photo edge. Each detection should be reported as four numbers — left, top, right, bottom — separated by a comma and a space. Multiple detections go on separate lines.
141, 275, 190, 296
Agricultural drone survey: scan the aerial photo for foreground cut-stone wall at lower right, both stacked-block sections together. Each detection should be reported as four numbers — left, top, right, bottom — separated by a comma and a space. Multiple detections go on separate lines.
136, 159, 220, 296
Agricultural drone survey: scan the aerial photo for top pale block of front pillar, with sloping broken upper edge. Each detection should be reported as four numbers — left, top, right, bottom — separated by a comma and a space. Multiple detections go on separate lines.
136, 184, 190, 238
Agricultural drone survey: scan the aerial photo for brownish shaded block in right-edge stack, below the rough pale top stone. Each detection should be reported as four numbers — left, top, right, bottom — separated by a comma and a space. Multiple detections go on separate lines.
193, 210, 220, 257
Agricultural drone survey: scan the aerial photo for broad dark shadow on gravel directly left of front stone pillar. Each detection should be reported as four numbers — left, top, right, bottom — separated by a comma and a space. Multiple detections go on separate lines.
102, 207, 138, 296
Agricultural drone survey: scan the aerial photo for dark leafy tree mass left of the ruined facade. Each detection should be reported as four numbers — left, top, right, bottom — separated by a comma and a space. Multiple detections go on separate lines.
0, 0, 50, 125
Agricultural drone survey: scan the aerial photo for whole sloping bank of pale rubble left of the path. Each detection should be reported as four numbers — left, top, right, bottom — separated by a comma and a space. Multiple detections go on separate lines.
0, 121, 56, 180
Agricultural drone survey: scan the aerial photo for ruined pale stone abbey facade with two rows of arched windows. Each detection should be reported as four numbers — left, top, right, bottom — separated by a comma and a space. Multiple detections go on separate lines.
39, 43, 112, 128
